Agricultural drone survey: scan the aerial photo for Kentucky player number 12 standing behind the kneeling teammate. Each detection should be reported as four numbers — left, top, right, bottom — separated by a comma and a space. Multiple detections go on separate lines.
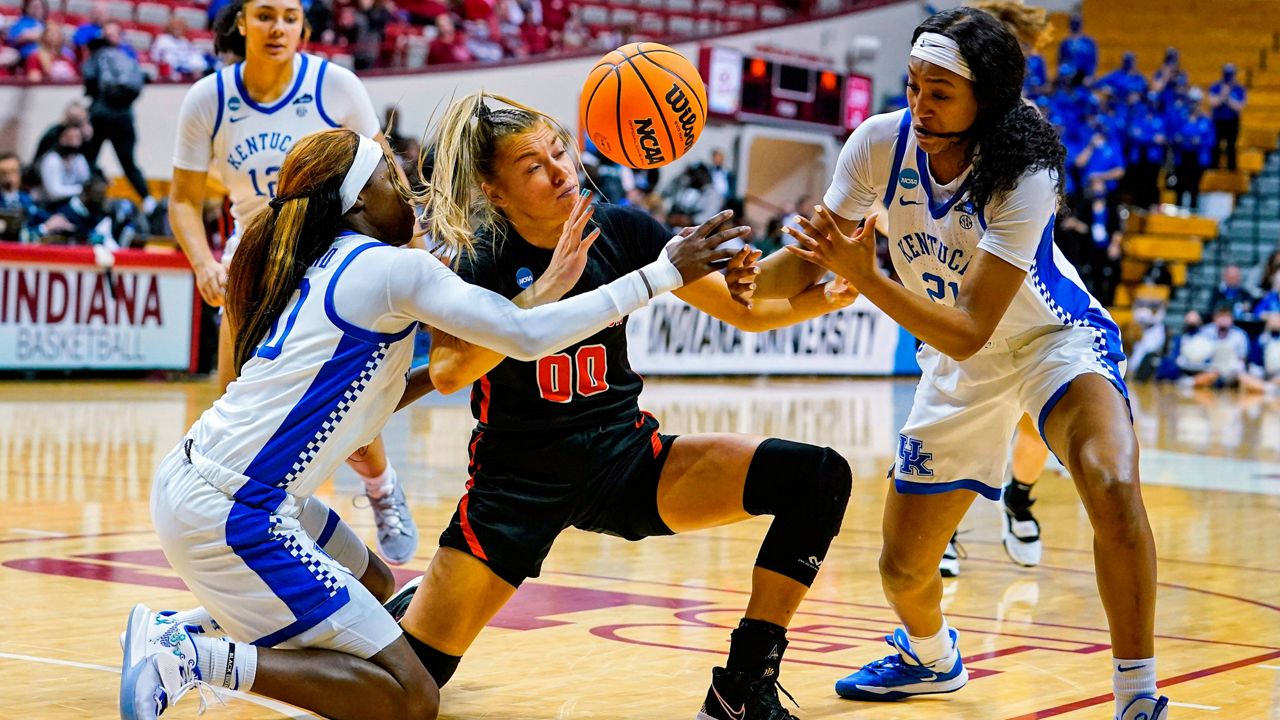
169, 0, 419, 565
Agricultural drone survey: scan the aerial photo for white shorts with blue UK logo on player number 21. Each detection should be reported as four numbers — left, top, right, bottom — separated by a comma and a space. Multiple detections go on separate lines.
892, 325, 1129, 500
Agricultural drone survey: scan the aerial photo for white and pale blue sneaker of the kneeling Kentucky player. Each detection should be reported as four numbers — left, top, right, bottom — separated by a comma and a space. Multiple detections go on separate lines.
120, 605, 205, 720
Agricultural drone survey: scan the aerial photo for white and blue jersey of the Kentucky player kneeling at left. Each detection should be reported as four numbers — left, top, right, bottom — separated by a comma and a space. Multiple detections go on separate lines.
189, 234, 416, 497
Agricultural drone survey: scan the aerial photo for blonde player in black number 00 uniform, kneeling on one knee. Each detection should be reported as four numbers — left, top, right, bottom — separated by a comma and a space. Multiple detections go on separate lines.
378, 94, 852, 720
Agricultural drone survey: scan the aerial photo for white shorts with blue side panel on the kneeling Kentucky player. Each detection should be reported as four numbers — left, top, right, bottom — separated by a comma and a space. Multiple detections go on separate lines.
151, 445, 401, 659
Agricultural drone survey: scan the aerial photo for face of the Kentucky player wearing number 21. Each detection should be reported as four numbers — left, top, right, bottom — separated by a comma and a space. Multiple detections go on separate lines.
906, 58, 978, 155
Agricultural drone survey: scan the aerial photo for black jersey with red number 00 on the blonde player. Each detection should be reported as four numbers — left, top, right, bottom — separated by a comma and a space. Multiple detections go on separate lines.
458, 205, 669, 432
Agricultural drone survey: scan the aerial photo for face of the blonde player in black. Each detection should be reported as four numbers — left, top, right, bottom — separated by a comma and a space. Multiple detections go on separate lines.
485, 124, 577, 222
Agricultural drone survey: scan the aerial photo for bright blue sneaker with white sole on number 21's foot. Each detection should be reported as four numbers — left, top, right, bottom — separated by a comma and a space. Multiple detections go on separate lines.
836, 628, 969, 701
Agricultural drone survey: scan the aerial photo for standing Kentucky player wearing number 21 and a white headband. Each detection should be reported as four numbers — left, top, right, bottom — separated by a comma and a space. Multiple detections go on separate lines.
731, 8, 1167, 720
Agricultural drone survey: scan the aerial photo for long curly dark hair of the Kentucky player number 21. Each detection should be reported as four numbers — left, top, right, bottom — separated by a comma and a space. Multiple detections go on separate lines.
911, 8, 1066, 208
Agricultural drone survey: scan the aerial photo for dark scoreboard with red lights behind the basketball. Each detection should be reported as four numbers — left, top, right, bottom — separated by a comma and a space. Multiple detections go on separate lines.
699, 46, 872, 135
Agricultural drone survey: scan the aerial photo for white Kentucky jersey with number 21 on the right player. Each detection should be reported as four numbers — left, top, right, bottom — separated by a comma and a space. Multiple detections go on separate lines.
826, 110, 1120, 352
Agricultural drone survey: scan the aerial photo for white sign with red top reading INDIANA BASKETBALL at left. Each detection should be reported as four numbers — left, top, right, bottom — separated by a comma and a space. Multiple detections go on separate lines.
0, 243, 196, 370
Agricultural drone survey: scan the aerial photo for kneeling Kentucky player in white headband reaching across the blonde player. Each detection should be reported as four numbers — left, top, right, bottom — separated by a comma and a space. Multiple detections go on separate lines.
120, 129, 733, 720
